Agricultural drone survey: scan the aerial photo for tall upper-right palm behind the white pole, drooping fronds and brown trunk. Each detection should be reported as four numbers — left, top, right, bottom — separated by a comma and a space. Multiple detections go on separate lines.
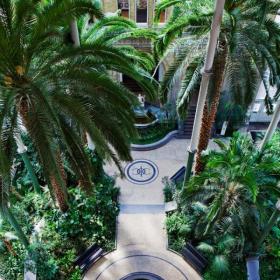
156, 0, 280, 176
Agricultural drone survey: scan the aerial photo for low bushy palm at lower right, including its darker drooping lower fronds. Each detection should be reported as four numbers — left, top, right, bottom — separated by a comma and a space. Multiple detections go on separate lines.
183, 134, 280, 279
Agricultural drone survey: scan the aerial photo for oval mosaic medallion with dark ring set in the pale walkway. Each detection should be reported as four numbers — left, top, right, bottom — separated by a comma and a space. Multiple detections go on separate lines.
125, 159, 158, 185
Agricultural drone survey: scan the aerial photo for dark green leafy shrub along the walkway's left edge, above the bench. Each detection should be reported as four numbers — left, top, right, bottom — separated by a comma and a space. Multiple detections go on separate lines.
46, 185, 118, 251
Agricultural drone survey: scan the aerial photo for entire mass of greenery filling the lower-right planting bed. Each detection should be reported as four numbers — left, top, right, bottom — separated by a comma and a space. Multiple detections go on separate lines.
167, 134, 280, 280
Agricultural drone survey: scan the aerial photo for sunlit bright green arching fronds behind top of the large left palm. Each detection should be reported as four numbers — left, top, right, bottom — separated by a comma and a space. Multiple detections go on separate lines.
78, 16, 157, 73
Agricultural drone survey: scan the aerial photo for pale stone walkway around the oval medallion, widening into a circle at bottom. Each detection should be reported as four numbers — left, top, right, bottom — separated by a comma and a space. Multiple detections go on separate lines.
84, 139, 219, 280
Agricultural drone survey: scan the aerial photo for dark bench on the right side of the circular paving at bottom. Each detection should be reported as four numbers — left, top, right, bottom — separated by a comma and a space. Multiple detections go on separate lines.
182, 243, 208, 274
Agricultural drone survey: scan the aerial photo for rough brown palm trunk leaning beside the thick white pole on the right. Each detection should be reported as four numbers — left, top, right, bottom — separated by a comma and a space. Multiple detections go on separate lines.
195, 41, 228, 173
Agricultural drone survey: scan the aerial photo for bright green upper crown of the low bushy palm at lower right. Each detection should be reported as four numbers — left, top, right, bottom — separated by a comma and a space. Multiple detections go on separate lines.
183, 133, 280, 234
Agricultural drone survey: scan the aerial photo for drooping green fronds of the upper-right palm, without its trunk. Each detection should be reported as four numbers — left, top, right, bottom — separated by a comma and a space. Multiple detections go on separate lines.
154, 0, 280, 119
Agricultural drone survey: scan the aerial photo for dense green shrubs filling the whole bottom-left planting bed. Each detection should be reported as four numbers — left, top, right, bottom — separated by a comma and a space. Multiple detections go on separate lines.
0, 182, 119, 280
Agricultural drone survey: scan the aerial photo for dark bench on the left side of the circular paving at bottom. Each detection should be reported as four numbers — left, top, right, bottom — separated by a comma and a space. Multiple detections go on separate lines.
73, 244, 104, 273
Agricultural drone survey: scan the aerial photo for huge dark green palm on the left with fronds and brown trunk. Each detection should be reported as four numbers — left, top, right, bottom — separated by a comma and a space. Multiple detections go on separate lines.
0, 0, 158, 211
